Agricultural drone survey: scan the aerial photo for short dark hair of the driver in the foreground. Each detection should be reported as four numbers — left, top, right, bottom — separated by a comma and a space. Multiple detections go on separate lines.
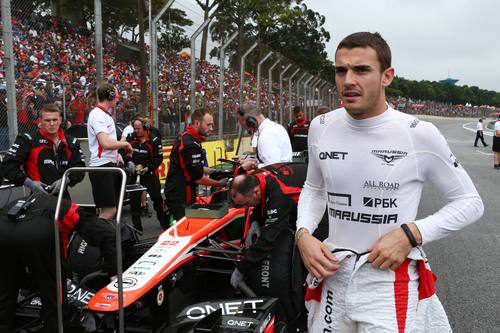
335, 31, 392, 72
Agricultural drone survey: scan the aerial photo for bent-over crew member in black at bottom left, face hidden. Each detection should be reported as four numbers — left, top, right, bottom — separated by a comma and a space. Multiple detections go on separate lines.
0, 193, 116, 333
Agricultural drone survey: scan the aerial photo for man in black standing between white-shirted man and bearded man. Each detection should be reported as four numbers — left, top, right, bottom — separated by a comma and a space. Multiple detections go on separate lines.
124, 118, 168, 231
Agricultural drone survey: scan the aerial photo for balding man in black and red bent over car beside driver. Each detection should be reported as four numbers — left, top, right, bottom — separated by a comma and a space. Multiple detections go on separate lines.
231, 162, 307, 329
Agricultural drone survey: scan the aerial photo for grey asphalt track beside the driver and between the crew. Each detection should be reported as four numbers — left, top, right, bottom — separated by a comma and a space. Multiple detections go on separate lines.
2, 117, 500, 333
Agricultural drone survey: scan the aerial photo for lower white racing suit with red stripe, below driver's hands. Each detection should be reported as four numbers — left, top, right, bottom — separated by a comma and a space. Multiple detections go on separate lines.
305, 243, 451, 333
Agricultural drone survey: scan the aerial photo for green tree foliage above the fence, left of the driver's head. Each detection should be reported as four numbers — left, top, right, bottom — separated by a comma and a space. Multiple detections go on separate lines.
210, 0, 333, 81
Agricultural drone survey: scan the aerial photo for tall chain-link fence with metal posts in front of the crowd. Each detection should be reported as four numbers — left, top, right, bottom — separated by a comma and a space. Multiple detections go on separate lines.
0, 0, 336, 150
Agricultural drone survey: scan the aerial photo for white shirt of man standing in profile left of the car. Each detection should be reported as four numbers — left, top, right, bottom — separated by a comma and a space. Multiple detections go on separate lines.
87, 106, 118, 166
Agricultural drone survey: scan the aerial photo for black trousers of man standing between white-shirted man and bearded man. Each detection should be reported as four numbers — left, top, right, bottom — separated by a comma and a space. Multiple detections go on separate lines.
130, 172, 168, 230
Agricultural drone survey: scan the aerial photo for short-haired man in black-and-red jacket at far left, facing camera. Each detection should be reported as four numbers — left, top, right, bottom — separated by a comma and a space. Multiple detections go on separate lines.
0, 104, 85, 197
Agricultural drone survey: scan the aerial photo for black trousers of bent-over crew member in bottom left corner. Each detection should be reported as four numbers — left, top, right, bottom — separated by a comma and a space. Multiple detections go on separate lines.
0, 216, 66, 333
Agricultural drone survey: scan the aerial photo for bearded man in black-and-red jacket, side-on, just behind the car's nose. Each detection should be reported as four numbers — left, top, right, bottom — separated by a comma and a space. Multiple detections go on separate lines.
165, 109, 227, 221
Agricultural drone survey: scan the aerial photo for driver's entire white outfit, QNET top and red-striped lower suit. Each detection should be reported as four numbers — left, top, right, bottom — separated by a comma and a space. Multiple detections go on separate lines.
297, 108, 484, 333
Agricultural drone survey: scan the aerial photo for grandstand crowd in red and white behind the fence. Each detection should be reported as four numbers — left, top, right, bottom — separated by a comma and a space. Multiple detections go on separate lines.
0, 11, 498, 143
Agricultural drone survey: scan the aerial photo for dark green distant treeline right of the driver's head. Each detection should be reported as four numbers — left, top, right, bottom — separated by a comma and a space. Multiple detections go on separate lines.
386, 76, 500, 107
